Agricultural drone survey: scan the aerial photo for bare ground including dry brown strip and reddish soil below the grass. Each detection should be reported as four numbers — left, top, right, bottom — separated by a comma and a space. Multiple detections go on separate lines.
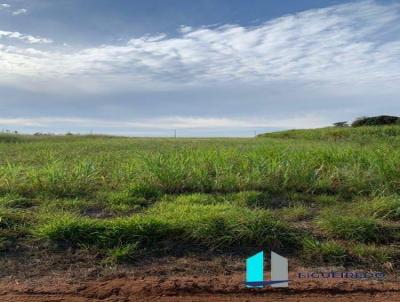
0, 254, 400, 302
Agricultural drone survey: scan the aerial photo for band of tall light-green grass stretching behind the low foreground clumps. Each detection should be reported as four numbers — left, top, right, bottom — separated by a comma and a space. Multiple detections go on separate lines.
0, 134, 400, 197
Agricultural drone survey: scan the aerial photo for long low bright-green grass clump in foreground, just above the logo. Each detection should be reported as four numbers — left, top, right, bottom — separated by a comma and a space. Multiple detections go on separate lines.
36, 201, 296, 254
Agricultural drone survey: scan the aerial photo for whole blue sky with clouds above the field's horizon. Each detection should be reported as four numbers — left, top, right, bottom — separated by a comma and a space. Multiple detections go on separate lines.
0, 0, 400, 136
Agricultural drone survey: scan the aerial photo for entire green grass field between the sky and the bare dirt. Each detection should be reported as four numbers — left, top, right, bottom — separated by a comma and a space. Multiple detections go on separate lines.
0, 126, 400, 269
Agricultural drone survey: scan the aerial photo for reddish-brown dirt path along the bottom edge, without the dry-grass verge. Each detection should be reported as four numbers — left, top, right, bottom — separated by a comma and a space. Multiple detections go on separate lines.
0, 274, 400, 302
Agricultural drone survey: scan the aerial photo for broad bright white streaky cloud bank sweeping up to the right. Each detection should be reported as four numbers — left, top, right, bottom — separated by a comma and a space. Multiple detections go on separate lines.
0, 1, 400, 92
